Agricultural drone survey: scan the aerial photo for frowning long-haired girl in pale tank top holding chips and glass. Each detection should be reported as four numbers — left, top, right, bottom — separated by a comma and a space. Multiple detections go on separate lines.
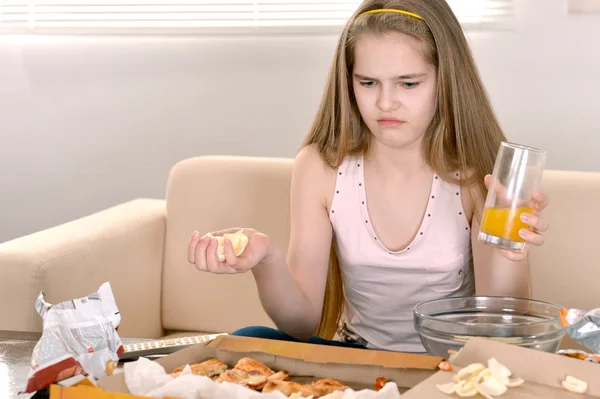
188, 0, 548, 352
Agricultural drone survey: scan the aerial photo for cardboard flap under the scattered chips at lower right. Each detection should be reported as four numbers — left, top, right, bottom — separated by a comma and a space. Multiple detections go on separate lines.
402, 338, 600, 399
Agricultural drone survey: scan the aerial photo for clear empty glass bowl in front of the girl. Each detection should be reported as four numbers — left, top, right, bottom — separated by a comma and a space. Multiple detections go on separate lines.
414, 296, 566, 358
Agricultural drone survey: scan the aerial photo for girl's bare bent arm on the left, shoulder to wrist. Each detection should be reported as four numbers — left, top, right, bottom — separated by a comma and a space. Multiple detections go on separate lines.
252, 147, 335, 340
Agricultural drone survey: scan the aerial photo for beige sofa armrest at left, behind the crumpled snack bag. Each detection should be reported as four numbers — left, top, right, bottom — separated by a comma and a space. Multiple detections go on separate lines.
0, 199, 166, 338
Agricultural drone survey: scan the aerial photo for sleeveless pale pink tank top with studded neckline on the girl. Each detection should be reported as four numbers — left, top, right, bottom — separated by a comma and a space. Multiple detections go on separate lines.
329, 157, 475, 353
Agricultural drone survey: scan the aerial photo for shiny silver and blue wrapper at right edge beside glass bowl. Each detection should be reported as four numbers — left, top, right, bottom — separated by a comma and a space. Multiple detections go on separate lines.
558, 308, 600, 363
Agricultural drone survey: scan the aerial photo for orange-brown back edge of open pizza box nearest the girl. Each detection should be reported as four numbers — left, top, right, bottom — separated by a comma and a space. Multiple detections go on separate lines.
207, 335, 444, 370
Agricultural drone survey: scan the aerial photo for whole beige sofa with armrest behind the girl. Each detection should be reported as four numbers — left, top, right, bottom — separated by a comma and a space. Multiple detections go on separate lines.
0, 156, 600, 346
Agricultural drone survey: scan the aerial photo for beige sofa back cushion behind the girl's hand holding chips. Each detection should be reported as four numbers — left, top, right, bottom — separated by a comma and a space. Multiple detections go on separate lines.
162, 156, 293, 333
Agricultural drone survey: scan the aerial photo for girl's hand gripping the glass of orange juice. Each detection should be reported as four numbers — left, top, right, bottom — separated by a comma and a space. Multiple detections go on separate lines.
486, 175, 550, 262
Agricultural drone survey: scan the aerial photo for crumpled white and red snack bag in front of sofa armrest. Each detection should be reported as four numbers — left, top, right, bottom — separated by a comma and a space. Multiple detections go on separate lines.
25, 282, 124, 393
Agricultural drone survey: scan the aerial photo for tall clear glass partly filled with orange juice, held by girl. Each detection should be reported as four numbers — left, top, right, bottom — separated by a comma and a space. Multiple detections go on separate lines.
478, 142, 546, 252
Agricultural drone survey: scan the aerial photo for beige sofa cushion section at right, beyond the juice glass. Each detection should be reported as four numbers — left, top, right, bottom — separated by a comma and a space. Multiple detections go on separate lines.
530, 170, 600, 309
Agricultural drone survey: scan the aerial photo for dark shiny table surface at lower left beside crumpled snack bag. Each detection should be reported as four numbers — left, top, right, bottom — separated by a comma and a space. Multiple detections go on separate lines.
0, 331, 155, 399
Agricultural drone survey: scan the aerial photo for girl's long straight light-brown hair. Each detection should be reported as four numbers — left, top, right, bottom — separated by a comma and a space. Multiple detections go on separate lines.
302, 0, 505, 338
